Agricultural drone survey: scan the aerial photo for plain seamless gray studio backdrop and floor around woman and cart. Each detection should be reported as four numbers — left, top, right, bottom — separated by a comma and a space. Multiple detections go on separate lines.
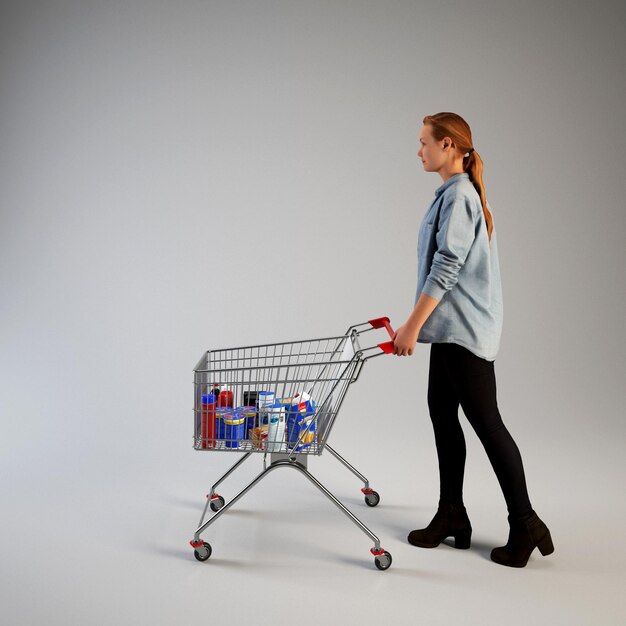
0, 0, 626, 625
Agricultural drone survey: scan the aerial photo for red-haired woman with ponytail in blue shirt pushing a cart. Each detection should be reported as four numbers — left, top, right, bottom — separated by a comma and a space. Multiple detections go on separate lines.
394, 113, 554, 567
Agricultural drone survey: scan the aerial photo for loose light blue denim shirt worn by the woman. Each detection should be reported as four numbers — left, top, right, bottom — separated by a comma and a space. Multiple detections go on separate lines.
415, 172, 503, 361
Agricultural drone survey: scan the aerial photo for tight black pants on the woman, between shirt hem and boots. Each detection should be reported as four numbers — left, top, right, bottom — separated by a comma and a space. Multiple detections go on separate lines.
428, 343, 532, 517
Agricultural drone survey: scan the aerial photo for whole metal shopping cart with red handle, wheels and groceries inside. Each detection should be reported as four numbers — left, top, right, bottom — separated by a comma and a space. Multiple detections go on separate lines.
190, 317, 393, 570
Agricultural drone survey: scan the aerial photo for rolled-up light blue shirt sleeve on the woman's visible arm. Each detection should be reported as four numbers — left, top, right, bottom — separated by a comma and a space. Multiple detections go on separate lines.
422, 195, 476, 300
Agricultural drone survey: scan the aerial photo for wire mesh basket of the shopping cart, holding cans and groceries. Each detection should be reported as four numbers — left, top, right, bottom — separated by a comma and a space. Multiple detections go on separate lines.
194, 333, 363, 454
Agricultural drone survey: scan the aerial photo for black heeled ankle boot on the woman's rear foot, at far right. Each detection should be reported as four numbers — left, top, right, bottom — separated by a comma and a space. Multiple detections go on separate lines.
491, 511, 554, 567
